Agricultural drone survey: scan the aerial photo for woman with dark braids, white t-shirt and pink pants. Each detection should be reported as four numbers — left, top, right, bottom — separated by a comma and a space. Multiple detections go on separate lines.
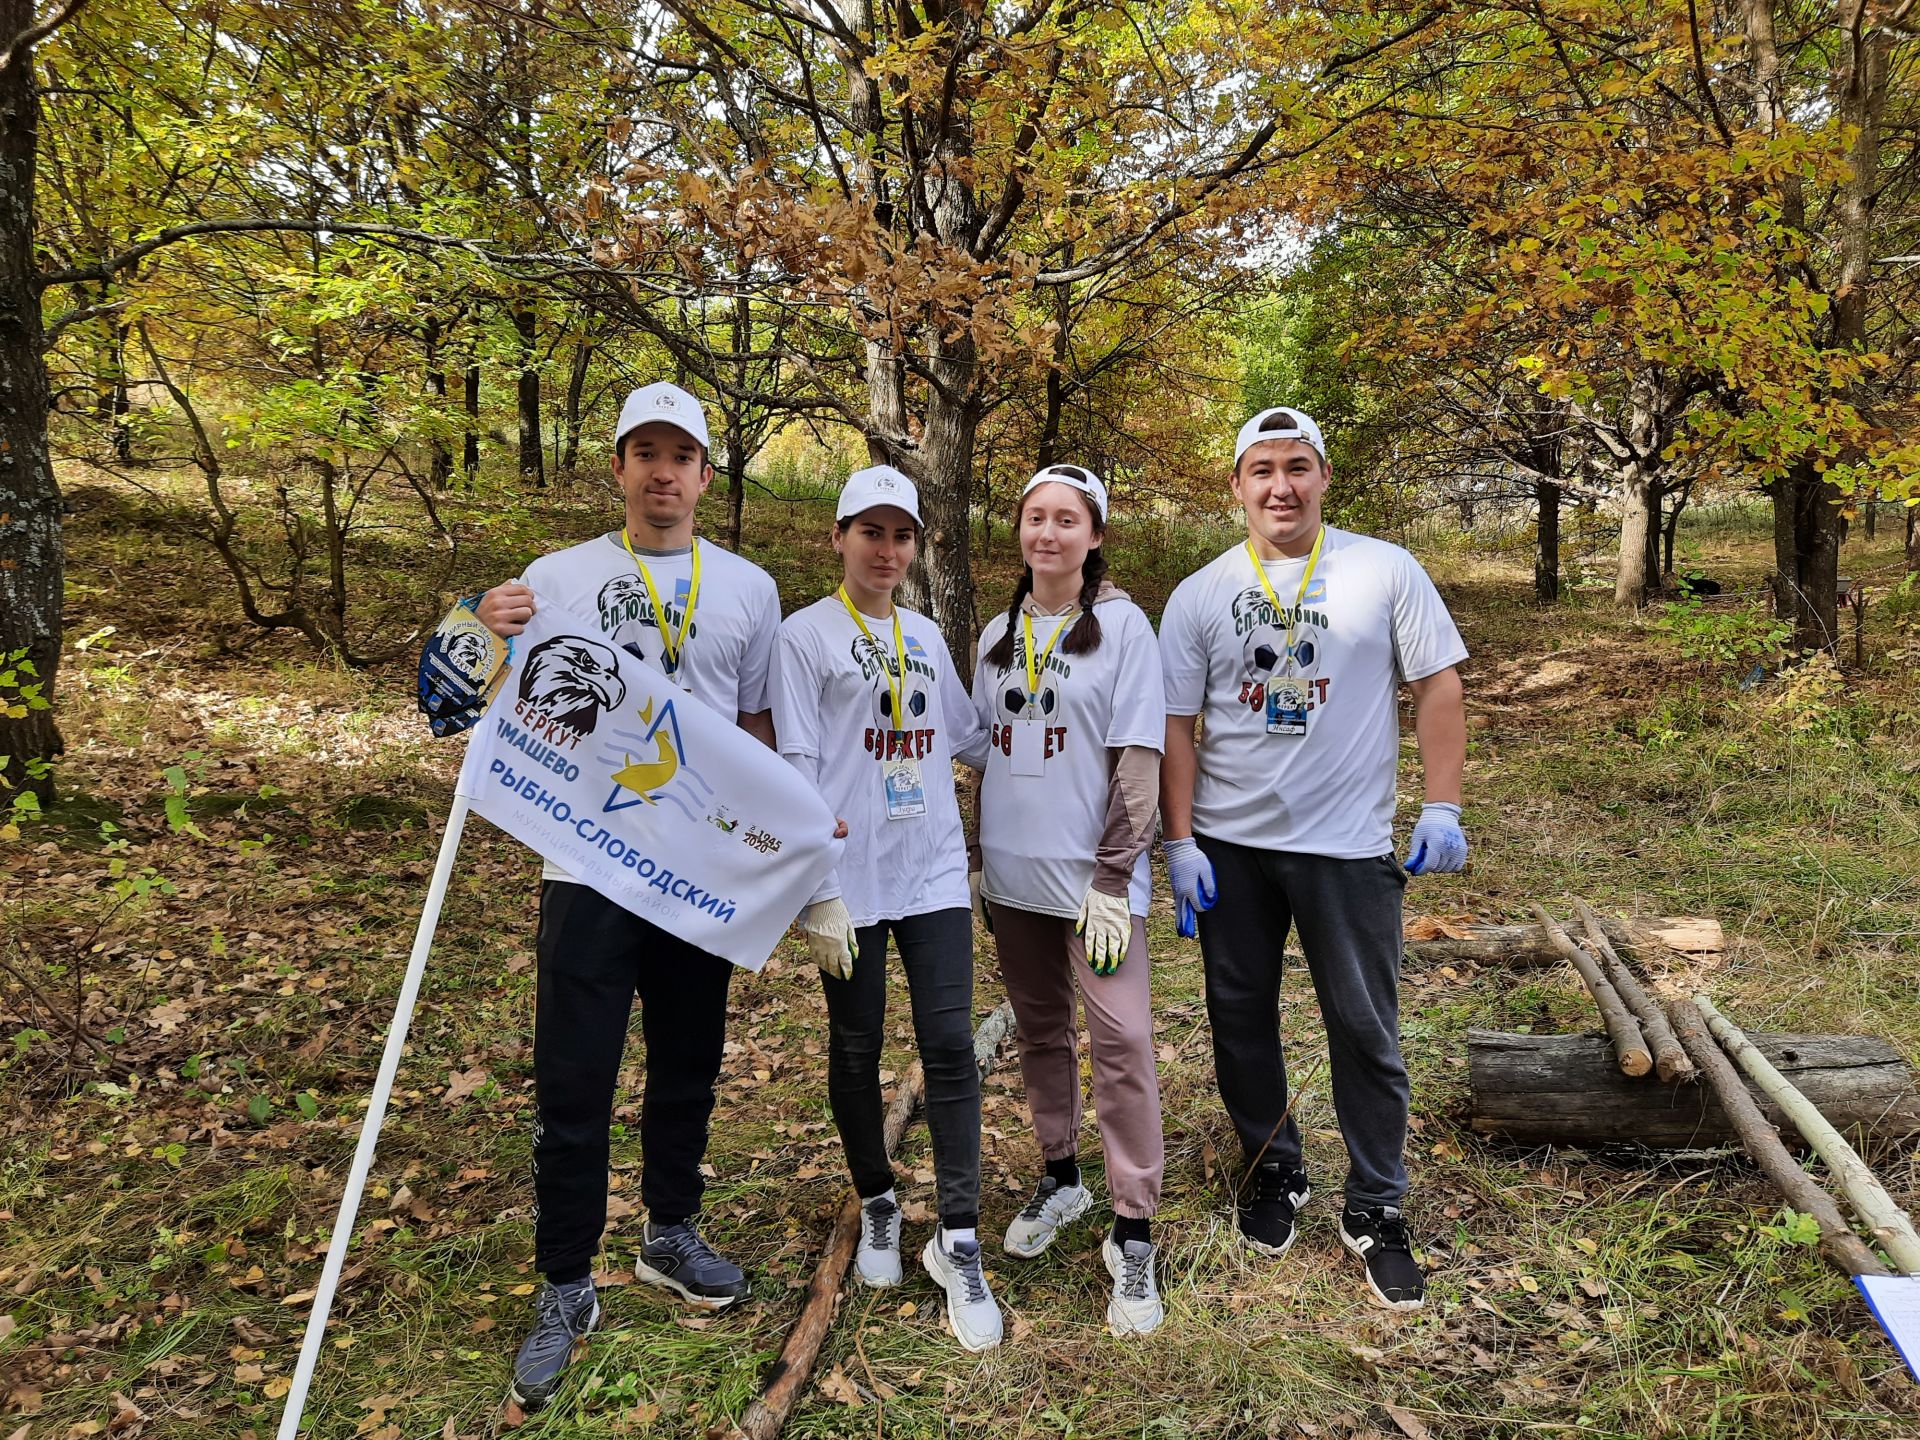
970, 465, 1165, 1334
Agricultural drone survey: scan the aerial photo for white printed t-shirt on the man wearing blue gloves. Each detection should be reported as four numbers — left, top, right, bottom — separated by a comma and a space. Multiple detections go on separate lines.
1160, 526, 1467, 860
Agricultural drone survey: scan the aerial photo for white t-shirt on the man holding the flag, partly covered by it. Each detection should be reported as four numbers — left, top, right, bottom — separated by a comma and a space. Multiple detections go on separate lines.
520, 530, 780, 879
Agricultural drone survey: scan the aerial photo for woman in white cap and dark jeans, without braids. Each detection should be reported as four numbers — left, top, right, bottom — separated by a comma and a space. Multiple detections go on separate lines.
774, 465, 1002, 1350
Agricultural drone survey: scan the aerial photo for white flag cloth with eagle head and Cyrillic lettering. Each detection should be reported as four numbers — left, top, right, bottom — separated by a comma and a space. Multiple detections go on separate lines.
459, 603, 843, 970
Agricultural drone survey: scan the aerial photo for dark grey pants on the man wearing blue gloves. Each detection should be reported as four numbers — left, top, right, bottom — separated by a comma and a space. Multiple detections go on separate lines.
1194, 835, 1409, 1206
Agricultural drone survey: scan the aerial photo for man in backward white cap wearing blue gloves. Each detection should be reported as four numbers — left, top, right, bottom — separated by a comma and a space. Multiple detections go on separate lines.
1160, 409, 1467, 1309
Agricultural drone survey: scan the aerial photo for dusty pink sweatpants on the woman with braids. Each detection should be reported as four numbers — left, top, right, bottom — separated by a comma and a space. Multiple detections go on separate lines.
989, 902, 1165, 1219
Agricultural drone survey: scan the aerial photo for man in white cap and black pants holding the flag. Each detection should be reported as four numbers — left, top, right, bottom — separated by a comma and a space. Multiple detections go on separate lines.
460, 384, 780, 1411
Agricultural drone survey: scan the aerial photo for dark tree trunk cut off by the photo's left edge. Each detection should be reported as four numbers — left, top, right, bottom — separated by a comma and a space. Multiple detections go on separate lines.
0, 0, 65, 806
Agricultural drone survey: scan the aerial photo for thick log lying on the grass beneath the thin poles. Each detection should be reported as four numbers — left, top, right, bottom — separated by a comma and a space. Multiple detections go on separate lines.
1467, 1029, 1920, 1150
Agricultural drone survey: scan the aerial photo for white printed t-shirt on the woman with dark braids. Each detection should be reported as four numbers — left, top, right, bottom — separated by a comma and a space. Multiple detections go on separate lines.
973, 595, 1167, 920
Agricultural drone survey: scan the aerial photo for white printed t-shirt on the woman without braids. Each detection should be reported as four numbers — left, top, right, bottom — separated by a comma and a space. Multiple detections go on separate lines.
772, 595, 985, 925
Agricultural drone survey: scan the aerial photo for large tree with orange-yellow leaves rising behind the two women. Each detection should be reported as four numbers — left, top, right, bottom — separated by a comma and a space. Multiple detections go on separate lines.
564, 0, 1430, 649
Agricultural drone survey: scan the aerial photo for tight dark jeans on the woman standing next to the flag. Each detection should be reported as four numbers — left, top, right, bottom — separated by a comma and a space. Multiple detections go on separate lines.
822, 910, 979, 1229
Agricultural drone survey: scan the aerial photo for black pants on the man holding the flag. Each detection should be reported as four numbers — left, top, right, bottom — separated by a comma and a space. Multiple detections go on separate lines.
534, 881, 733, 1275
